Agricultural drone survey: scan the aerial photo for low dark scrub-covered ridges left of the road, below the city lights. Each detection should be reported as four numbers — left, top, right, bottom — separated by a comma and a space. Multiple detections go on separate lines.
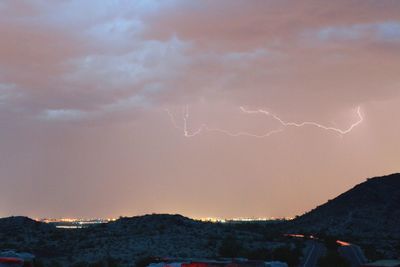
0, 214, 296, 266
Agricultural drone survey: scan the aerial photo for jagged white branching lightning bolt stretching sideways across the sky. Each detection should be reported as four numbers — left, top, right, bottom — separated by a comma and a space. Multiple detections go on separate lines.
166, 105, 364, 138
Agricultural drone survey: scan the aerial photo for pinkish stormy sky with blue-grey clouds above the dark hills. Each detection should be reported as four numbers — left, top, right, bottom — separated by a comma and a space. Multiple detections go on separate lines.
0, 0, 400, 218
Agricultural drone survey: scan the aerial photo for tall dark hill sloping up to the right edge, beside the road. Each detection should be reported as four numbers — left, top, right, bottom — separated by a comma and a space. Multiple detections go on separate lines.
291, 173, 400, 238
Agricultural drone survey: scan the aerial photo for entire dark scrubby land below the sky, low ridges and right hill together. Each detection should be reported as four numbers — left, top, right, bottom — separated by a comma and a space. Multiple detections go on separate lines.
0, 174, 400, 266
